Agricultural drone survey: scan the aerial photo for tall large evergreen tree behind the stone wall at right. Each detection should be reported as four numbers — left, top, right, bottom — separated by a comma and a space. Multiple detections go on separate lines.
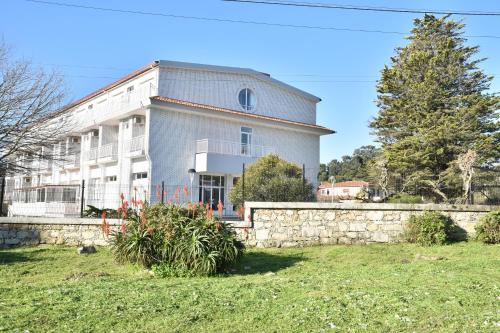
370, 15, 500, 201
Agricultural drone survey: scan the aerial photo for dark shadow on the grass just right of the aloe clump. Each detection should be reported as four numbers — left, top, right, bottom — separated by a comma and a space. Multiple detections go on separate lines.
230, 252, 307, 275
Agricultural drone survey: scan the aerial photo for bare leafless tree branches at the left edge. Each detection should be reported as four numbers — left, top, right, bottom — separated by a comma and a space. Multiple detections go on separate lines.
0, 43, 72, 176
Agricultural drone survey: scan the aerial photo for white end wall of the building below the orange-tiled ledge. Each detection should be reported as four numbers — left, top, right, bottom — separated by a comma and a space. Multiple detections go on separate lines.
149, 108, 319, 204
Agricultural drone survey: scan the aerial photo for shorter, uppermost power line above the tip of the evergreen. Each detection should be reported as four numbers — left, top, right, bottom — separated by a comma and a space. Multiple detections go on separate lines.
222, 0, 500, 16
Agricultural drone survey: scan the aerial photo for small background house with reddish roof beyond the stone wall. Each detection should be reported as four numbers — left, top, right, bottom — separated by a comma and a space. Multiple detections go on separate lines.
317, 180, 382, 201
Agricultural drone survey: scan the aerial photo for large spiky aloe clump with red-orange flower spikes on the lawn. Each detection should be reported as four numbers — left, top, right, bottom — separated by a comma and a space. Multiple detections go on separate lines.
110, 195, 244, 276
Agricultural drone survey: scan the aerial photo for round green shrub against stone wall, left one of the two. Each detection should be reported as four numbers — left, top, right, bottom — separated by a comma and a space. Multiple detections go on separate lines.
404, 211, 454, 246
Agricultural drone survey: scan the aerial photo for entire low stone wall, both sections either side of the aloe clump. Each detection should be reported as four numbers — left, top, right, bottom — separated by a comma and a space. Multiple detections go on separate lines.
0, 202, 499, 247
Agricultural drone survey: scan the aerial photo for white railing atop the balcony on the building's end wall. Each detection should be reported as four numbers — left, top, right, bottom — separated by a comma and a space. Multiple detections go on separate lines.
196, 139, 275, 157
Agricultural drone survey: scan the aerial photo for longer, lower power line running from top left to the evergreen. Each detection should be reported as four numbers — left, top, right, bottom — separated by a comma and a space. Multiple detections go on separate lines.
24, 0, 500, 39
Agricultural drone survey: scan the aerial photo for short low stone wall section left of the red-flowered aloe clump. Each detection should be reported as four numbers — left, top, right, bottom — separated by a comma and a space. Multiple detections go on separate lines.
0, 217, 119, 248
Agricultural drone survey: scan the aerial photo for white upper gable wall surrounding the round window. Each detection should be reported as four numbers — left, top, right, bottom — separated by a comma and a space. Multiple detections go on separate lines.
158, 68, 316, 124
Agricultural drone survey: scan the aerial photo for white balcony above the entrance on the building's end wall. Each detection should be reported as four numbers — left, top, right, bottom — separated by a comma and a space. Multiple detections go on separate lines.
196, 139, 275, 174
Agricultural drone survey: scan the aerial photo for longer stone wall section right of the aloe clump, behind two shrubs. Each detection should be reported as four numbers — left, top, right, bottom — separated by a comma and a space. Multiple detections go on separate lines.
237, 202, 500, 247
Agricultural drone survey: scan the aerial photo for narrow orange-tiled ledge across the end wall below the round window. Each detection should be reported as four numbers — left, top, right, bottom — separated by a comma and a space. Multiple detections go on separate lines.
151, 96, 335, 134
